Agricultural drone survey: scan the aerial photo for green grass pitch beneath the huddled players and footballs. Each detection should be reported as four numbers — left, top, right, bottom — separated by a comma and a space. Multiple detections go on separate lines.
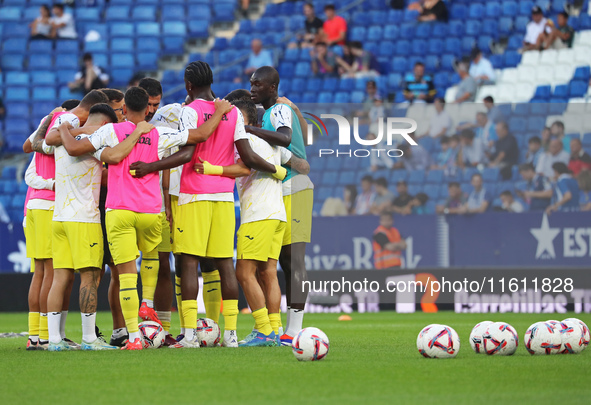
0, 312, 591, 405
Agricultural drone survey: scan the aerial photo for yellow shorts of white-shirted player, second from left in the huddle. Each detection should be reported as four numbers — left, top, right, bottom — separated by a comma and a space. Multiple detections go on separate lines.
53, 221, 104, 270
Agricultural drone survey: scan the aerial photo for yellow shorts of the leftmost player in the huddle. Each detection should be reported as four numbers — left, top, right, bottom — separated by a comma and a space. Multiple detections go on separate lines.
25, 210, 53, 260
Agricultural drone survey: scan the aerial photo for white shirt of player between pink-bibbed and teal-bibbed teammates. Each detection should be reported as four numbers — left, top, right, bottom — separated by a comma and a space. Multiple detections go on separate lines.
236, 134, 291, 223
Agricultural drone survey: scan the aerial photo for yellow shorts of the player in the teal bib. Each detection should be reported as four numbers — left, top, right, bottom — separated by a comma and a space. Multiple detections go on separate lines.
283, 189, 314, 246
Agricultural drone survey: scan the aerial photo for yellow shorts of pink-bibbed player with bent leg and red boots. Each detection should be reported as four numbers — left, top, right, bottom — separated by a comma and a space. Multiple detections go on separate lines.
107, 210, 162, 265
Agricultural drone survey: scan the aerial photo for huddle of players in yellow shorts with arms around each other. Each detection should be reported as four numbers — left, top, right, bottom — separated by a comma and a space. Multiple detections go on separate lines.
23, 61, 314, 351
